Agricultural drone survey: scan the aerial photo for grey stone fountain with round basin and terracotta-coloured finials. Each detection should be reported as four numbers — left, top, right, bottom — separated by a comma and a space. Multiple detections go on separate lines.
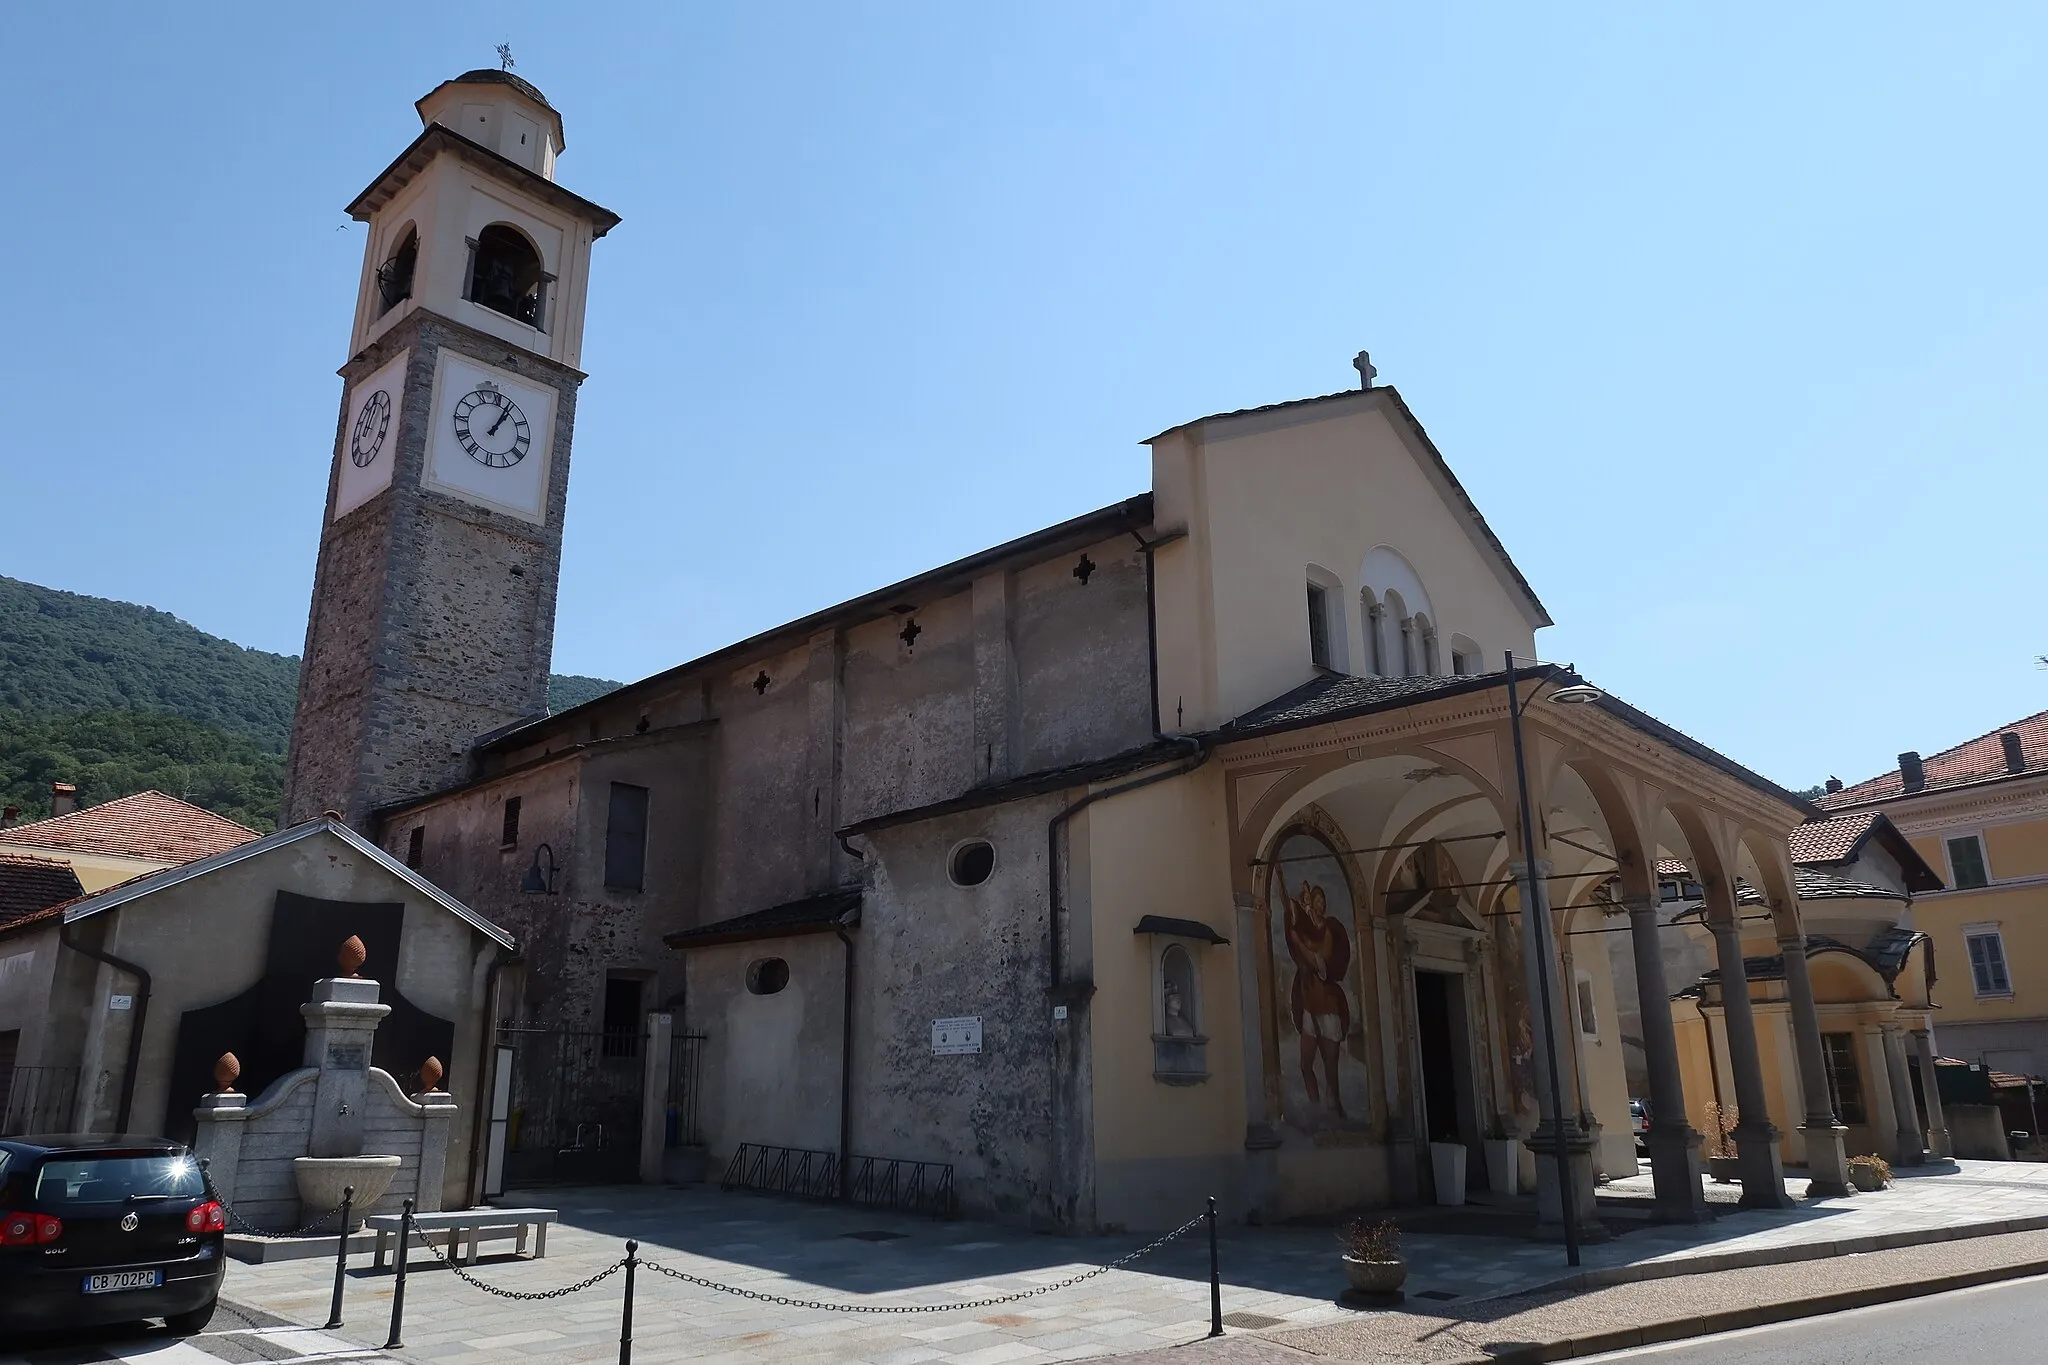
193, 937, 457, 1236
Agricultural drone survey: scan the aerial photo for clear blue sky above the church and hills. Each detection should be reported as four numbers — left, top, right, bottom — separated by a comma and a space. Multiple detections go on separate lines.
0, 0, 2048, 786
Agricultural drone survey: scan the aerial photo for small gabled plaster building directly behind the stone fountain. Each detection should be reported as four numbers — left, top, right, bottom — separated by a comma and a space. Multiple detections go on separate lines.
0, 821, 512, 1205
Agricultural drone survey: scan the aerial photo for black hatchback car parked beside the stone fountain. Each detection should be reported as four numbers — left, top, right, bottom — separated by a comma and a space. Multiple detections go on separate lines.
0, 1136, 227, 1340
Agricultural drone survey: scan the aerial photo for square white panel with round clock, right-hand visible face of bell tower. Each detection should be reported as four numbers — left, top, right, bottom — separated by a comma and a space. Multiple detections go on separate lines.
420, 348, 557, 522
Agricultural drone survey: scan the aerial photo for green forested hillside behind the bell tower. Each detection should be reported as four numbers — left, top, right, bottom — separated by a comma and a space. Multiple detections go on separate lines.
0, 577, 618, 831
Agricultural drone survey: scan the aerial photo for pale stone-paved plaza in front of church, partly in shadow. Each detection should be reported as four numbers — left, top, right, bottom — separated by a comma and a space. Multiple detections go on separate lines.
88, 1162, 2048, 1365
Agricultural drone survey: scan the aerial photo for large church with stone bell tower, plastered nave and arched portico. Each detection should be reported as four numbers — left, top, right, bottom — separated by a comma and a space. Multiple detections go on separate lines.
287, 72, 1875, 1230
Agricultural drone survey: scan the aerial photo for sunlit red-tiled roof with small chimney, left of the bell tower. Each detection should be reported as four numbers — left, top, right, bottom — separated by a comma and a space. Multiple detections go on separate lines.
0, 784, 258, 890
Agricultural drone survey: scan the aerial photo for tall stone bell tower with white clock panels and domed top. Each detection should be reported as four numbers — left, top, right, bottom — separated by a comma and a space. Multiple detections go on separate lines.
283, 70, 618, 829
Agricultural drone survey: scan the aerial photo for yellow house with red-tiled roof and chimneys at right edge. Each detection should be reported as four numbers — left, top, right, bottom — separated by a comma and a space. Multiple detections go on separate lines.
1821, 712, 2048, 1076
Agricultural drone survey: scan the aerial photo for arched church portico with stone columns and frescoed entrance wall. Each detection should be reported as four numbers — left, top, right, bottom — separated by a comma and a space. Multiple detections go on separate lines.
1219, 669, 1845, 1236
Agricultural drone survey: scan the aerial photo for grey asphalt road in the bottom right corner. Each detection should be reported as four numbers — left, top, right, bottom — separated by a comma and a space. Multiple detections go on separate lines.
1581, 1277, 2048, 1365
